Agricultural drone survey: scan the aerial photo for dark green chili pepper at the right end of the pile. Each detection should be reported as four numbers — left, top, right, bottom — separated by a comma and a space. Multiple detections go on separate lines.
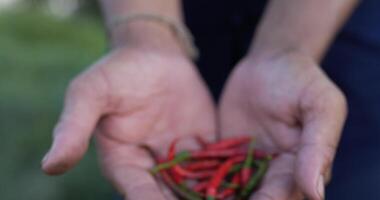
240, 160, 269, 198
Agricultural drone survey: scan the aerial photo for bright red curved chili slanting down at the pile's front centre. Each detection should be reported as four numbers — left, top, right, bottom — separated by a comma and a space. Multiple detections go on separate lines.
207, 156, 244, 200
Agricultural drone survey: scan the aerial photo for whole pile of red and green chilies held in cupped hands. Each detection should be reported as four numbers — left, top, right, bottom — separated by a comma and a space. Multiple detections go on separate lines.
151, 137, 272, 200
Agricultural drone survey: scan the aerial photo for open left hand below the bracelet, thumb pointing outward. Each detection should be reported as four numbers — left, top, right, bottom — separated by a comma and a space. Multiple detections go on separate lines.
43, 45, 215, 200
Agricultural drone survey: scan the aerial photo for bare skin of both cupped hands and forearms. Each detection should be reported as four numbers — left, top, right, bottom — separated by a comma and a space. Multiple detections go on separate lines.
42, 0, 355, 200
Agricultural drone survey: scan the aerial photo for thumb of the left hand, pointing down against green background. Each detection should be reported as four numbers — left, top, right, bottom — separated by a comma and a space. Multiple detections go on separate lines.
42, 78, 104, 175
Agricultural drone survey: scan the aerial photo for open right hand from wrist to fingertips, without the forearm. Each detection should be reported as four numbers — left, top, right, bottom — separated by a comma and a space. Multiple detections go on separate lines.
220, 52, 346, 200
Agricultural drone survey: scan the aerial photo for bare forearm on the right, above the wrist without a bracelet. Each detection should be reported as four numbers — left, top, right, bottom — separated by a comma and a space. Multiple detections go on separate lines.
250, 0, 358, 61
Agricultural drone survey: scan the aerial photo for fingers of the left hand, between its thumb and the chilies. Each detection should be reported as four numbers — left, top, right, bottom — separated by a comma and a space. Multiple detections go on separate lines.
96, 134, 173, 200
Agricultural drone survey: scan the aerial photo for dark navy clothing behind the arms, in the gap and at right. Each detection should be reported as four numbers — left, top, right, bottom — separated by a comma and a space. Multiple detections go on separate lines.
183, 0, 380, 200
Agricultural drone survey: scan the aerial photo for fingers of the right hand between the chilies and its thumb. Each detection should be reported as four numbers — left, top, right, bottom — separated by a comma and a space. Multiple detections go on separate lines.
251, 154, 302, 200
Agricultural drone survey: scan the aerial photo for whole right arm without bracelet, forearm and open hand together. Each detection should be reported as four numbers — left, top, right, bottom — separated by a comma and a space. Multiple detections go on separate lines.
220, 0, 357, 200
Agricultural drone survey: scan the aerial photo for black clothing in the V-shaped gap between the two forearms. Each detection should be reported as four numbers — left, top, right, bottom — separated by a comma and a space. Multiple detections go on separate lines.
183, 0, 266, 99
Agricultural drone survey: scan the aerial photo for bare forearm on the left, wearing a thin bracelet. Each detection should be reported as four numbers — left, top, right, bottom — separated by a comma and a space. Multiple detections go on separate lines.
99, 0, 182, 50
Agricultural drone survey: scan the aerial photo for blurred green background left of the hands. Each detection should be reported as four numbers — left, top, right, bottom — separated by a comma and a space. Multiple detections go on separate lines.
0, 0, 113, 200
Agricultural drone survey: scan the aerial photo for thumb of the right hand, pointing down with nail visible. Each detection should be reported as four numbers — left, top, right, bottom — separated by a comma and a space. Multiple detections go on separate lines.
296, 88, 346, 200
